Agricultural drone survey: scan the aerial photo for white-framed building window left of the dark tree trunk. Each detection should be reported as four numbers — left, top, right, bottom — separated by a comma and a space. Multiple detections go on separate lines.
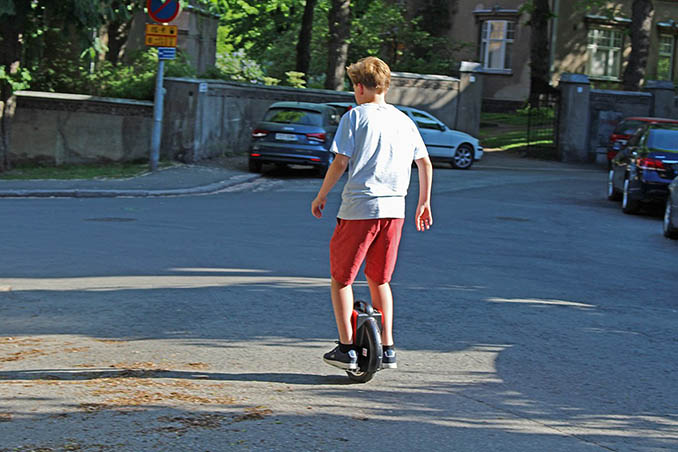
480, 20, 515, 72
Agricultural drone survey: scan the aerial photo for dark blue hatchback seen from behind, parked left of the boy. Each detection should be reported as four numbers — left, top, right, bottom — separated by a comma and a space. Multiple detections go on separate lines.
249, 102, 340, 176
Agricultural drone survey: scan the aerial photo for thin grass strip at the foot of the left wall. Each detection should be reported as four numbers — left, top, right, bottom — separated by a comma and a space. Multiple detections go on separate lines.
0, 161, 173, 180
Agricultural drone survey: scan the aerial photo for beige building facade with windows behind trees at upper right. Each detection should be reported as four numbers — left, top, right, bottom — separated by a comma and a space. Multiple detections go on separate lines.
414, 0, 678, 103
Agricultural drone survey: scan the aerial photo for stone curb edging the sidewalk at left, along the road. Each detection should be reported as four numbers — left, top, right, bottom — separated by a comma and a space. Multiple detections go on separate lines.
0, 175, 261, 198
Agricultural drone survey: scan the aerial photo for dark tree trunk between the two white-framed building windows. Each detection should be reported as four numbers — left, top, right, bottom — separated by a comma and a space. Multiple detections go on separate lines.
530, 0, 553, 103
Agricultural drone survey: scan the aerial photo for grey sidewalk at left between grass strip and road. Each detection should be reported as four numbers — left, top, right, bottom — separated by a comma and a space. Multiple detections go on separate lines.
0, 158, 260, 198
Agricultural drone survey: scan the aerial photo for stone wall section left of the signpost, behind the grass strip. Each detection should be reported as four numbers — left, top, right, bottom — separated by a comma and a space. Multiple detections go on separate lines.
9, 91, 153, 165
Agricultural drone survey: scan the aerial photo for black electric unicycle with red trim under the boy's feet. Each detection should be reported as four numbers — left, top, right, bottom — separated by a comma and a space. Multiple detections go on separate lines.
346, 301, 384, 383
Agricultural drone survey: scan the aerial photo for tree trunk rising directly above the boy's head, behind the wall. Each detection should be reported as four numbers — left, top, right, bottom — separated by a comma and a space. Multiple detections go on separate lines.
325, 0, 351, 91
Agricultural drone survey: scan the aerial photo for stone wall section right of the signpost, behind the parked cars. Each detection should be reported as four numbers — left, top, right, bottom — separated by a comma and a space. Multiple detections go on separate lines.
161, 63, 482, 162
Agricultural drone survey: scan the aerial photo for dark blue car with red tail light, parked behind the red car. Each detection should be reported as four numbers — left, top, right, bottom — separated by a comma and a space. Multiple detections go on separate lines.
607, 124, 678, 213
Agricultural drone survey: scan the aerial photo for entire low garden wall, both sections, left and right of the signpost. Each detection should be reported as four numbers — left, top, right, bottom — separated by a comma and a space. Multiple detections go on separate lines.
9, 63, 482, 165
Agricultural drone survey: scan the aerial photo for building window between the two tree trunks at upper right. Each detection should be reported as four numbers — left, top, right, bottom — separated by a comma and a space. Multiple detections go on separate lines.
586, 28, 622, 80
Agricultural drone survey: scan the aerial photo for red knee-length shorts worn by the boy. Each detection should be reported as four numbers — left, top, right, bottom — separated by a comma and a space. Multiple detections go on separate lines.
330, 218, 405, 285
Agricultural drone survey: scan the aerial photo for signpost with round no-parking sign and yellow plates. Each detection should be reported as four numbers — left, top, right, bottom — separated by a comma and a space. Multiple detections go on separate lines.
146, 0, 181, 171
